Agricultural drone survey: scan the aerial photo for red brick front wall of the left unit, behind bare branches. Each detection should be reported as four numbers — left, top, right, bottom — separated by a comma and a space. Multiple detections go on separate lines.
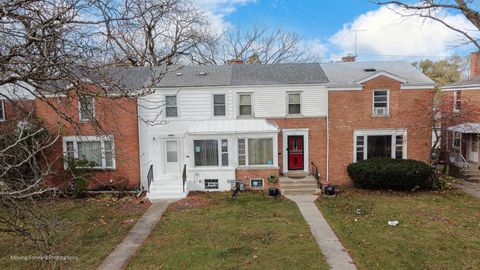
35, 87, 140, 189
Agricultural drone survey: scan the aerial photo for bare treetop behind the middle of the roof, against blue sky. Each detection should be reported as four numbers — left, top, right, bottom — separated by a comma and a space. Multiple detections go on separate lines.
201, 24, 316, 64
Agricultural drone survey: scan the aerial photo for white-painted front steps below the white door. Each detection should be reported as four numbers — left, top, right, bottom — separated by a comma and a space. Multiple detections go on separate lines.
147, 176, 188, 200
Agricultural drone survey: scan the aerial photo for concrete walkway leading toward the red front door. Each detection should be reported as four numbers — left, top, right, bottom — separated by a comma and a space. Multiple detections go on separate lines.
286, 195, 357, 270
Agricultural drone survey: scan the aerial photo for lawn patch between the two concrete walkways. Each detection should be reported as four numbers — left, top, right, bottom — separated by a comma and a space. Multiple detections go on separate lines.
128, 192, 328, 269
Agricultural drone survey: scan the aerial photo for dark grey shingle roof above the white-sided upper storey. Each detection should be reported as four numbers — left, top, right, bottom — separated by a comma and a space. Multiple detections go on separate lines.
156, 63, 328, 87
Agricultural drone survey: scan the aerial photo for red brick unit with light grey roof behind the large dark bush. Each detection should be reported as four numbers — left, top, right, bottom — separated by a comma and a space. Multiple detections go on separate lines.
322, 61, 435, 184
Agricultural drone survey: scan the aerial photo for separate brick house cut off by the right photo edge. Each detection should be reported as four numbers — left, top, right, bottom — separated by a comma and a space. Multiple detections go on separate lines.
441, 52, 480, 180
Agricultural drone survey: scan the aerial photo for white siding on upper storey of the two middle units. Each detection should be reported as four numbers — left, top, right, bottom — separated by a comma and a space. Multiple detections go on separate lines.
139, 85, 328, 121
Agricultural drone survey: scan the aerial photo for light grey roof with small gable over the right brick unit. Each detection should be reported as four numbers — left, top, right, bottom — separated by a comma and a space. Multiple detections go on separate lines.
321, 61, 435, 89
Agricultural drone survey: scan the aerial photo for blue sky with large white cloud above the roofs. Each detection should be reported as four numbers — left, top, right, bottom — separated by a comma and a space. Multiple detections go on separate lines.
194, 0, 475, 62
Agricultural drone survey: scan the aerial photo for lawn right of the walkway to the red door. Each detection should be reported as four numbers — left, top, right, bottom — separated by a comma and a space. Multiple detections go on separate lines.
317, 189, 480, 269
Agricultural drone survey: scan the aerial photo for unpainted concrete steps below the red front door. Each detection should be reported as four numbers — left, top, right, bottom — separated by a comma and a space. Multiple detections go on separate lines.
279, 172, 320, 195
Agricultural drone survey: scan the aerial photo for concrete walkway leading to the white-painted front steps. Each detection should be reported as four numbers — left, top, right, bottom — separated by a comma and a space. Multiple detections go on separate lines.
97, 200, 173, 270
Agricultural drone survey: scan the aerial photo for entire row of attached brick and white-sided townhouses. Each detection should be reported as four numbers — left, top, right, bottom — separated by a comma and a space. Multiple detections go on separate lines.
1, 59, 434, 198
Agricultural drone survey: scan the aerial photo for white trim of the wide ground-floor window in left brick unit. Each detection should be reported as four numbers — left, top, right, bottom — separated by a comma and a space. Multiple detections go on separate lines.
62, 135, 117, 170
